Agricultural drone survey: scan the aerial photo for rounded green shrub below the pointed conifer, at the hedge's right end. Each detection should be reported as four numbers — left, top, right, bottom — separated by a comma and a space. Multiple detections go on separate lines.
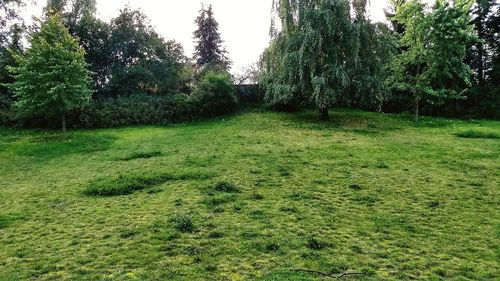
192, 71, 238, 117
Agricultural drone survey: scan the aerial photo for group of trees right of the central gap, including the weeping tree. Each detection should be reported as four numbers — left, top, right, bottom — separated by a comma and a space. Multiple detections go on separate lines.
261, 0, 500, 120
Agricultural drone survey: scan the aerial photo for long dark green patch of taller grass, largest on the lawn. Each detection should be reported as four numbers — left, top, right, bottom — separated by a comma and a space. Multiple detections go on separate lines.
83, 170, 210, 196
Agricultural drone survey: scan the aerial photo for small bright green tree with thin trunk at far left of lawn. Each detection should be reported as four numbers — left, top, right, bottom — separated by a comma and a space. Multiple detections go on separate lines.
9, 15, 91, 132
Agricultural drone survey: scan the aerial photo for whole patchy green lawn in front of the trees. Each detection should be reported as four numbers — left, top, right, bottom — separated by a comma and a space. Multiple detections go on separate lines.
0, 106, 500, 281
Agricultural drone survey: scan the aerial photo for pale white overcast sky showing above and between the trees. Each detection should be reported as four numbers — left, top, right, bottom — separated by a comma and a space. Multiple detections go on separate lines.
20, 0, 434, 72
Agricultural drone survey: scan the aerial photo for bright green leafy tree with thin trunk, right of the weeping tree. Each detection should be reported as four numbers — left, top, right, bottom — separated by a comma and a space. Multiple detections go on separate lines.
388, 0, 474, 120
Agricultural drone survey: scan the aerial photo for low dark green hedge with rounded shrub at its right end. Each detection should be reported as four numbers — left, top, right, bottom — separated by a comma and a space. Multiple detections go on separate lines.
74, 71, 237, 128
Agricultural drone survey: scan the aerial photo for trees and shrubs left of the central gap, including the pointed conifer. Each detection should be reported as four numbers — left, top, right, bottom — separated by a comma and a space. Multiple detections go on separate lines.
0, 0, 236, 129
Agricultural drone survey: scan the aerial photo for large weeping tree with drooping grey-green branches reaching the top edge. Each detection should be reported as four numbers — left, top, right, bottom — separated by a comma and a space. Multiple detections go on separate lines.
261, 0, 394, 120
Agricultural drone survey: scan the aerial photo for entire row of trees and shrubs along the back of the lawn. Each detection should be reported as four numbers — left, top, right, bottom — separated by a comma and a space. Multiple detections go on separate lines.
0, 0, 500, 131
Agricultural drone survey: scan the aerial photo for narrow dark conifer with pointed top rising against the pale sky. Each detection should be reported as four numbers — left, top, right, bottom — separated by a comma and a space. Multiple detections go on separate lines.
194, 5, 231, 70
